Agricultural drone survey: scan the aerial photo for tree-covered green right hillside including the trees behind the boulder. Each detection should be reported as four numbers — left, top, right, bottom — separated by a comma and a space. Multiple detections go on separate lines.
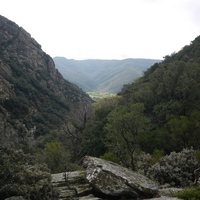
82, 34, 200, 169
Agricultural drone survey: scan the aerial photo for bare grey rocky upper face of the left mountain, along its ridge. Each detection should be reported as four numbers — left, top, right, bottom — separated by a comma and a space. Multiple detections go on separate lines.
0, 15, 88, 103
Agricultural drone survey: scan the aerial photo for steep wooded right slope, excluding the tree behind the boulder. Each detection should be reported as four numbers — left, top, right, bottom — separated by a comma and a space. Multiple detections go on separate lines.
120, 36, 200, 153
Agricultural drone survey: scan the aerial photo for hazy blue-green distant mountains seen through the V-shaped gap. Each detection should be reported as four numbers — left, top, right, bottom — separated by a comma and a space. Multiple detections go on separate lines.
53, 57, 160, 93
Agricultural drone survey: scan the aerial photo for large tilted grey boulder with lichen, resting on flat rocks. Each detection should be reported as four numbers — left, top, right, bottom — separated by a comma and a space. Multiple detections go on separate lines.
83, 156, 159, 197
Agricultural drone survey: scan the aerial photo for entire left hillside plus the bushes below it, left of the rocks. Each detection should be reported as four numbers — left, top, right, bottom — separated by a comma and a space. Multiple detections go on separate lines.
0, 16, 92, 200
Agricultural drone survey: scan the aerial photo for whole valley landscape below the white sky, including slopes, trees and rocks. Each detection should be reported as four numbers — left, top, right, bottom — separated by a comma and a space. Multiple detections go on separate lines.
0, 16, 200, 200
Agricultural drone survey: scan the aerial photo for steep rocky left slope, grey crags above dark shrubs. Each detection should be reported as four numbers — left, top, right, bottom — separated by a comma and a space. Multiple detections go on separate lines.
0, 16, 91, 143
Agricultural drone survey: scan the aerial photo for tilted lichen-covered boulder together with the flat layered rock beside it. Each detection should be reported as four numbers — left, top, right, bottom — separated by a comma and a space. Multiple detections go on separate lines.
52, 156, 159, 200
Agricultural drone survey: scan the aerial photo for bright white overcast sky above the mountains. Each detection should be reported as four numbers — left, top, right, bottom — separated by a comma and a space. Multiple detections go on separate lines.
0, 0, 200, 59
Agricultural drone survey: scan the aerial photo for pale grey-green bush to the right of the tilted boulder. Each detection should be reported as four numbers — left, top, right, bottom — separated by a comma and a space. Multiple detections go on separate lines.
147, 148, 198, 186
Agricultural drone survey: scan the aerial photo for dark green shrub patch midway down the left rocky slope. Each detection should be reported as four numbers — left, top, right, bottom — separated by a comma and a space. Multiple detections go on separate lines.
2, 61, 69, 136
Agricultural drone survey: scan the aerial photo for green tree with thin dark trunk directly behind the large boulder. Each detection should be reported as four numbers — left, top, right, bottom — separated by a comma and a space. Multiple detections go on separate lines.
105, 103, 150, 170
